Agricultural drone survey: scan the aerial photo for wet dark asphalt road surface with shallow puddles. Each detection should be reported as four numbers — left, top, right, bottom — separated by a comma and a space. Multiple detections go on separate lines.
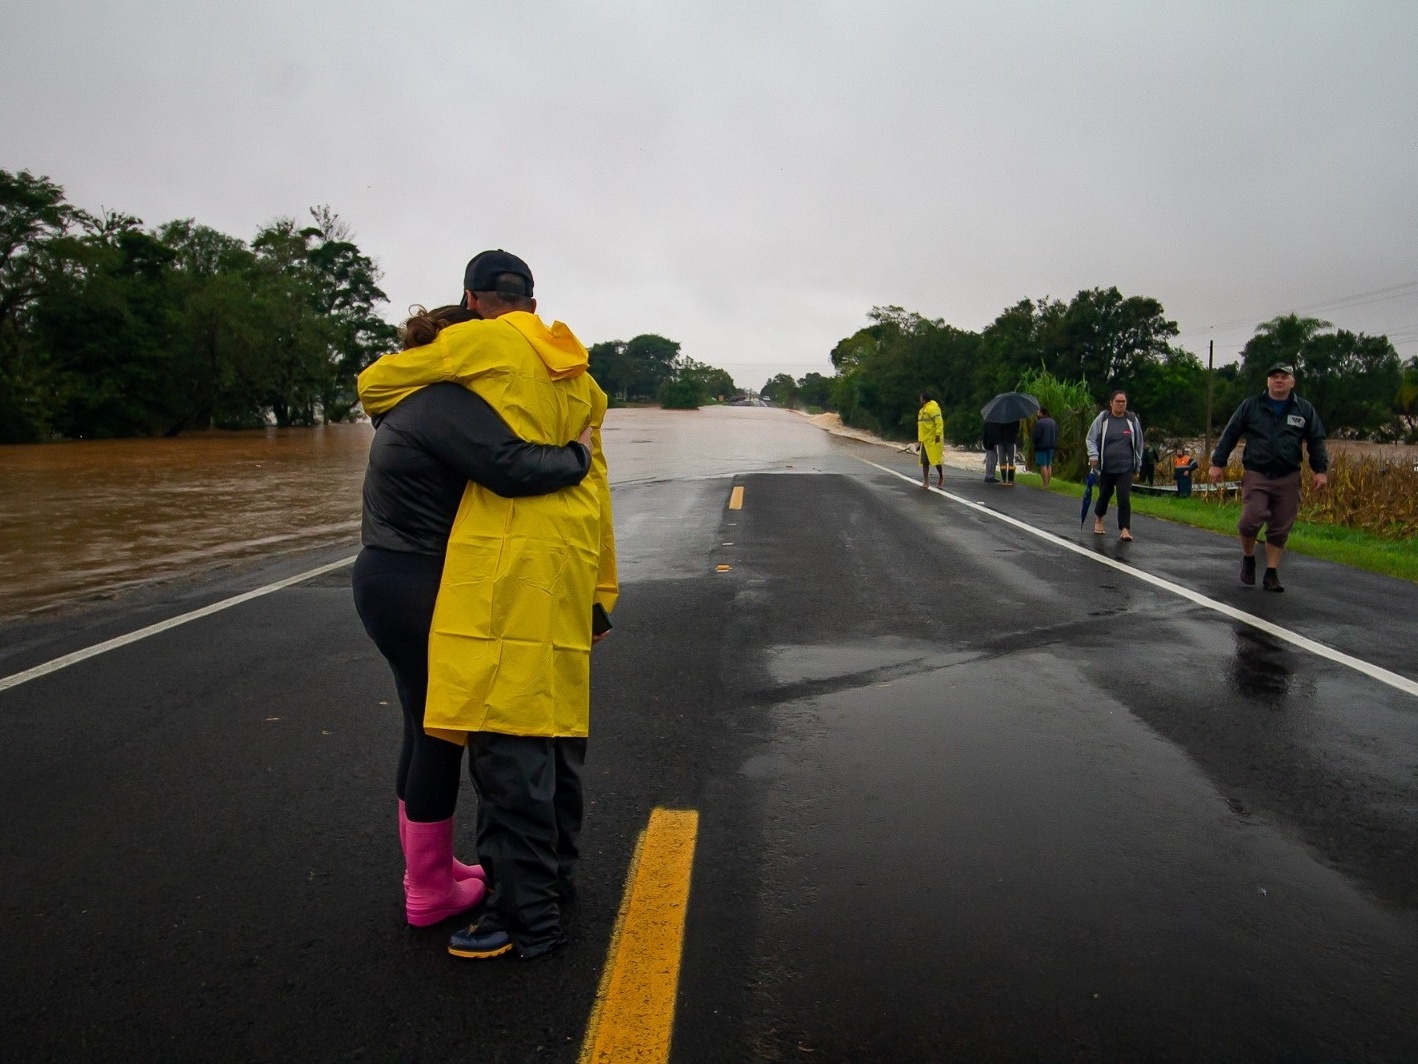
0, 419, 1418, 1064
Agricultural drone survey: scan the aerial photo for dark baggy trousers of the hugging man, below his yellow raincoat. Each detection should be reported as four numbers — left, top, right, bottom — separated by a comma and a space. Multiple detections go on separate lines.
468, 732, 586, 956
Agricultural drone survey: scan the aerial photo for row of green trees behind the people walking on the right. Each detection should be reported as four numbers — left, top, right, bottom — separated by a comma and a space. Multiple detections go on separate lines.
763, 288, 1418, 445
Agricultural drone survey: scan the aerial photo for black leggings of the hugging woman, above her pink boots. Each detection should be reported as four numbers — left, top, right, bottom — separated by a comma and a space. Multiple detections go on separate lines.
355, 546, 462, 824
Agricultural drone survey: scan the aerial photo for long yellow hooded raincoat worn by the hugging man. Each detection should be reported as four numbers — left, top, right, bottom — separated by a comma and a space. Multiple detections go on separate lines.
359, 312, 620, 738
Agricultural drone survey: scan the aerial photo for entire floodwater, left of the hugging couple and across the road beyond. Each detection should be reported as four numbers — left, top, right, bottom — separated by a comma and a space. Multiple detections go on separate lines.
0, 407, 831, 617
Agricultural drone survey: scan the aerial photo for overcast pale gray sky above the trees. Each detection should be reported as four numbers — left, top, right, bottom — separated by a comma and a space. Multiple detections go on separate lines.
0, 0, 1418, 387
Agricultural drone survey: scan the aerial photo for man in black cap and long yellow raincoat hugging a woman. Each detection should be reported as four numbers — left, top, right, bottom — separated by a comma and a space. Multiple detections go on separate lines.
359, 250, 618, 959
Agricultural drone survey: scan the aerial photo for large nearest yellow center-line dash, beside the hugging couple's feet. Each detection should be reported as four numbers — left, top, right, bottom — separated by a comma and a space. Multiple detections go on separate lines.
580, 805, 700, 1064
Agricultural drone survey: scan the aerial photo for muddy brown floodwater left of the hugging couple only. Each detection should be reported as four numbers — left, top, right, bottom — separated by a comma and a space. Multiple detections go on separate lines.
0, 424, 373, 617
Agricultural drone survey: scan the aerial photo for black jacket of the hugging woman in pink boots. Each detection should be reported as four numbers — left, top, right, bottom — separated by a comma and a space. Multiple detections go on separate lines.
360, 383, 591, 555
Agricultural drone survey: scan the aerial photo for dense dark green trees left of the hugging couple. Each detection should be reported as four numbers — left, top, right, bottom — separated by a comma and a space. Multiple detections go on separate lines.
0, 170, 396, 443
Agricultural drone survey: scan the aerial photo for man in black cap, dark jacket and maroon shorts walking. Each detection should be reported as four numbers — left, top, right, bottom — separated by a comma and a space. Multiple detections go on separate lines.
1207, 362, 1329, 592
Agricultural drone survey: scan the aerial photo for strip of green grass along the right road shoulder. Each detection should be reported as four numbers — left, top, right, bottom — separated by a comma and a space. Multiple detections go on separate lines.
1020, 474, 1418, 583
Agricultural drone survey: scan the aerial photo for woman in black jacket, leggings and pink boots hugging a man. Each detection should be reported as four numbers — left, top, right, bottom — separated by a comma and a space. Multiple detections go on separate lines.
353, 306, 591, 926
